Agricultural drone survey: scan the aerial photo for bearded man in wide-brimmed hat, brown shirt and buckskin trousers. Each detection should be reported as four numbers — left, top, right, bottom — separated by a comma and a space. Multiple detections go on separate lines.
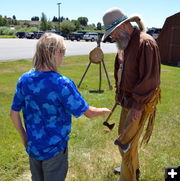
102, 8, 160, 181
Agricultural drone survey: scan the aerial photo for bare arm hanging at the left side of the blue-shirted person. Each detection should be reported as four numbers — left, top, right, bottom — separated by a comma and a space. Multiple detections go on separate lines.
10, 110, 27, 148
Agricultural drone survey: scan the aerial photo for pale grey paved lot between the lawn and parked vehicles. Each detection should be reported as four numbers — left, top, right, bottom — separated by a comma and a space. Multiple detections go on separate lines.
0, 39, 117, 61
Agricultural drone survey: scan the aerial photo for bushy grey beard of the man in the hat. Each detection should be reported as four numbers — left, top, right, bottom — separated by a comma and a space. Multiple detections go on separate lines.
116, 30, 131, 50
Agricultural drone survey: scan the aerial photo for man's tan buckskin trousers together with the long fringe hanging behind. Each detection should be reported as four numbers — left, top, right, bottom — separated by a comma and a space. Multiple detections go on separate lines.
118, 88, 161, 181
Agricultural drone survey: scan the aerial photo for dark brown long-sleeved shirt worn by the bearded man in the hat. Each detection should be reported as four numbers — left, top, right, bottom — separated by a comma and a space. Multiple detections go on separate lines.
114, 29, 160, 110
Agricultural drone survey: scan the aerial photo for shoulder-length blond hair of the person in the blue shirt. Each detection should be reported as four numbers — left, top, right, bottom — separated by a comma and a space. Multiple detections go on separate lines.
33, 33, 66, 71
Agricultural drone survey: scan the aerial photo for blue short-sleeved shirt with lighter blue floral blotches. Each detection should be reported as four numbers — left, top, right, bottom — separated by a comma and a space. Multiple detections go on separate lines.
11, 70, 89, 160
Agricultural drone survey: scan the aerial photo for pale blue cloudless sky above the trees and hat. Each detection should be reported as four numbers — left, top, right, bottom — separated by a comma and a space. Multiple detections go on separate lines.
0, 0, 180, 28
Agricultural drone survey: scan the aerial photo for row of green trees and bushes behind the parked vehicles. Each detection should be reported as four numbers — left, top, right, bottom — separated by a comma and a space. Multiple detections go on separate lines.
0, 13, 103, 33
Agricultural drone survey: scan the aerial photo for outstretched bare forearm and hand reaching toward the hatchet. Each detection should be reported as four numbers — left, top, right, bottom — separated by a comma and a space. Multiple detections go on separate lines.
84, 106, 111, 118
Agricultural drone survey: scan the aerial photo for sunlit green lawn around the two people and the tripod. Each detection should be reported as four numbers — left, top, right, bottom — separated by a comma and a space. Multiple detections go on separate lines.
0, 54, 180, 181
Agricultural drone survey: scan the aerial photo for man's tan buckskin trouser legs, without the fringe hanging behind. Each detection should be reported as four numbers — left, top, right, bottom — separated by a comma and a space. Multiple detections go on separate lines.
118, 108, 148, 181
